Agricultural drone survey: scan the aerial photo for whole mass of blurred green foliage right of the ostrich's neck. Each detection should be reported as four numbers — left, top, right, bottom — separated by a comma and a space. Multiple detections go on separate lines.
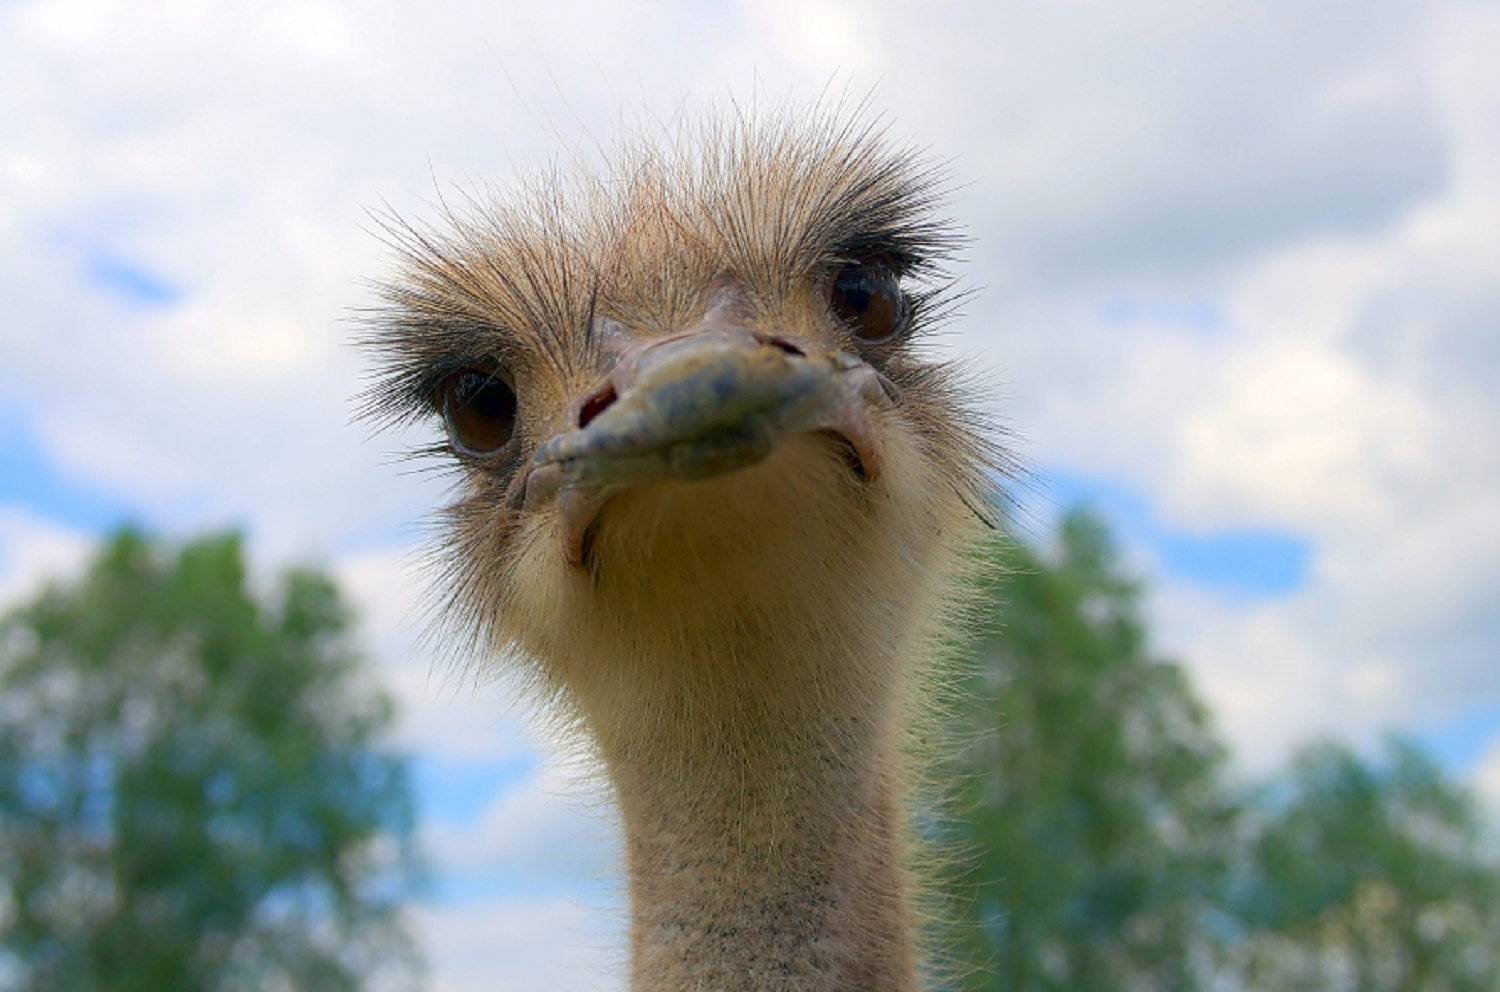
957, 513, 1500, 992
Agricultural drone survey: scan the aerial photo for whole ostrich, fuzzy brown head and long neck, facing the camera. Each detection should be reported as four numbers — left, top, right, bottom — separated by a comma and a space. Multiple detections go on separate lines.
366, 110, 1008, 992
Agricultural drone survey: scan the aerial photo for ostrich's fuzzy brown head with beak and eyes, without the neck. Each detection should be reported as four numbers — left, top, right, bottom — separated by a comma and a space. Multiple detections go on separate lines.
358, 112, 995, 693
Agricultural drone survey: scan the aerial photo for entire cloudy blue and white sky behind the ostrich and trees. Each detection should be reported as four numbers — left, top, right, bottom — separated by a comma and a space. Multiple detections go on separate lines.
0, 0, 1500, 992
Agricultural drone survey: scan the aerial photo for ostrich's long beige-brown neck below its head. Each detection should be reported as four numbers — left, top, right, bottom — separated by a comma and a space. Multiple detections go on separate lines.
582, 618, 917, 992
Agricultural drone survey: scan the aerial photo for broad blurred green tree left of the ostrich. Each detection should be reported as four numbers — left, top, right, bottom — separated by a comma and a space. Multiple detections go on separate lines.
0, 530, 416, 992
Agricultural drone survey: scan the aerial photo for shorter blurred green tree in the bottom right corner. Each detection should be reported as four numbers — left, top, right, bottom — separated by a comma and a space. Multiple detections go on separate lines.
1241, 738, 1500, 992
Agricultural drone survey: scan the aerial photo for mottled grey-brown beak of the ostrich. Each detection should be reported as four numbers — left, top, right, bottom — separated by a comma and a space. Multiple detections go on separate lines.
524, 320, 894, 564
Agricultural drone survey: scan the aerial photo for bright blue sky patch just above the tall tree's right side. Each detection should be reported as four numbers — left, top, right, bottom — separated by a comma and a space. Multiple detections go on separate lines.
1034, 470, 1313, 600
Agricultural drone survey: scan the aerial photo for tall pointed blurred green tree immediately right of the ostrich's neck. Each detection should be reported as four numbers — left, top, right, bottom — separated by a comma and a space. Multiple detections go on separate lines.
957, 513, 1236, 992
